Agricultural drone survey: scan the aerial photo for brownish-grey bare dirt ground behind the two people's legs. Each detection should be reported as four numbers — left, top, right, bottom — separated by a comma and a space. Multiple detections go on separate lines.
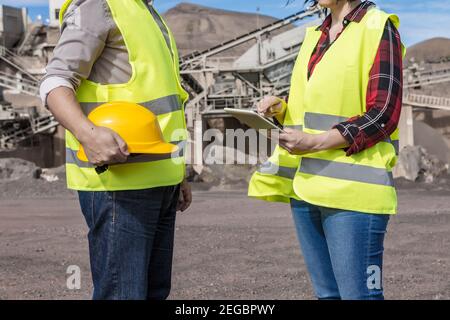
0, 185, 450, 299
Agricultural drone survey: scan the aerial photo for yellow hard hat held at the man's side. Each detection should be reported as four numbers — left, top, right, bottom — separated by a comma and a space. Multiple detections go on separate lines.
77, 102, 178, 162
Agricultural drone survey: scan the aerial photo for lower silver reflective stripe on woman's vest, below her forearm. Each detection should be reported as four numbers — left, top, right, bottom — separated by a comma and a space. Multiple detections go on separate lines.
299, 158, 394, 187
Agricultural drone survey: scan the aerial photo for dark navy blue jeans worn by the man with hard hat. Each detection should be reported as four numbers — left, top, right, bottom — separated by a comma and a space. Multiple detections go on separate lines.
79, 186, 179, 300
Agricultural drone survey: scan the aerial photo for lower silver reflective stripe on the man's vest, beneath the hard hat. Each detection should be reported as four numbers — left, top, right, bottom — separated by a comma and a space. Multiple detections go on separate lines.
66, 141, 186, 168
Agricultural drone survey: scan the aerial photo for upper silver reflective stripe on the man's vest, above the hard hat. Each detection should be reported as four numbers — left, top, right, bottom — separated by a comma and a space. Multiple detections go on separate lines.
80, 94, 183, 116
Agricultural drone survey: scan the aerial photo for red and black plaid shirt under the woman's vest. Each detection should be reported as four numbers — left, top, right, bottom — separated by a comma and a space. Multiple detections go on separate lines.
308, 1, 403, 156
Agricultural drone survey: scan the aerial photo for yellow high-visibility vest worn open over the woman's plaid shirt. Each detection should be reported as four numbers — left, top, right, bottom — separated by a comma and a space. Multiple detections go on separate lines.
249, 8, 405, 214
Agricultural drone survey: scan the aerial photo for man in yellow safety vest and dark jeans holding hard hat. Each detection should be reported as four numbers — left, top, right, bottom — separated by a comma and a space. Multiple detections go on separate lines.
40, 0, 192, 299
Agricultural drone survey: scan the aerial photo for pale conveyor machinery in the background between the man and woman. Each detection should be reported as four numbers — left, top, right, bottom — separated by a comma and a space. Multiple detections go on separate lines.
180, 7, 322, 127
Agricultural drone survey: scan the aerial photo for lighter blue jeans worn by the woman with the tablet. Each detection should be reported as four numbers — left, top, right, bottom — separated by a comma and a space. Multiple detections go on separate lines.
291, 200, 389, 300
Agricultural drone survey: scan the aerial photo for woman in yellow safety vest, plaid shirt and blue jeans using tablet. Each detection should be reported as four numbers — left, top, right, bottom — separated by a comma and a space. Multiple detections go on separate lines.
249, 0, 405, 299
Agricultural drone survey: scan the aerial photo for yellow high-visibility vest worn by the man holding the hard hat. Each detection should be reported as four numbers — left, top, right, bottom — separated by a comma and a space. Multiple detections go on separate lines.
60, 0, 188, 191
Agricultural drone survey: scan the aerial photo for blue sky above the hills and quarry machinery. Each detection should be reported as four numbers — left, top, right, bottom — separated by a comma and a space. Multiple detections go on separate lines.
0, 0, 450, 46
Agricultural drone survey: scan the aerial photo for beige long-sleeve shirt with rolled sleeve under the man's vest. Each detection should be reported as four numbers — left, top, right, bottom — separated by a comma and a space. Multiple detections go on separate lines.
40, 0, 170, 105
